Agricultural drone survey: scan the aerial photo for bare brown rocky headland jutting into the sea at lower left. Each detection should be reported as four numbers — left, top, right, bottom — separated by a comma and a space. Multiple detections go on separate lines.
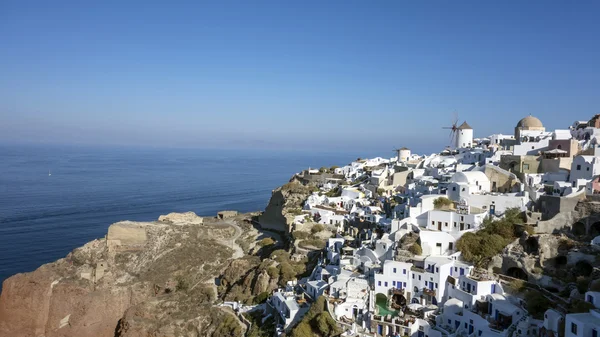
0, 213, 250, 337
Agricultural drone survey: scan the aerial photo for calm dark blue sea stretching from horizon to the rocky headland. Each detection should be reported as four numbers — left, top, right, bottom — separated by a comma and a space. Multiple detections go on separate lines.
0, 145, 364, 282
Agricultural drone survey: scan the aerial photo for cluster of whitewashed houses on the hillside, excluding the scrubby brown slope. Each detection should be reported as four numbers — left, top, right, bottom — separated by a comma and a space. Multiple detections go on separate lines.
268, 115, 600, 337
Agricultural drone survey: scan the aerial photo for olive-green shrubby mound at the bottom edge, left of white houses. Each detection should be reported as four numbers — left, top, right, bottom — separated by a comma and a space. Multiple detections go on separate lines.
291, 296, 342, 337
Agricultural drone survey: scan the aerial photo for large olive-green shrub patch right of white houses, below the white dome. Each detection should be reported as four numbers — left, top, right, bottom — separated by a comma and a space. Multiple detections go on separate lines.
456, 208, 523, 267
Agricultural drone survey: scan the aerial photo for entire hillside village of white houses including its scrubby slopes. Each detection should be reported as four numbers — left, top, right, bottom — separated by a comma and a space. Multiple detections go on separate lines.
254, 115, 600, 337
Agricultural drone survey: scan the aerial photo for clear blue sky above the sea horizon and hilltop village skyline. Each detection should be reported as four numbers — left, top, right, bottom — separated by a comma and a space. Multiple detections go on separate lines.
0, 0, 600, 151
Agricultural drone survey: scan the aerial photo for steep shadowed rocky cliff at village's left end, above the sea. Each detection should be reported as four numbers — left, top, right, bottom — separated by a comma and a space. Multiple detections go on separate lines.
258, 179, 312, 233
